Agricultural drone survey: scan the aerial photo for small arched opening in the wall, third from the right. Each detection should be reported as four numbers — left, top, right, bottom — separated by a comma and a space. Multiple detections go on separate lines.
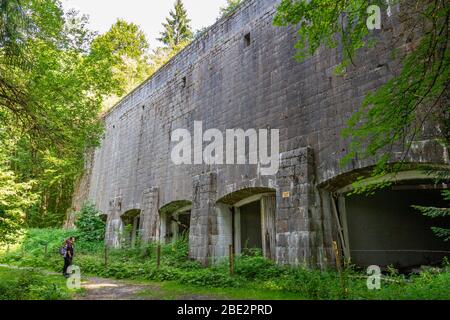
159, 200, 192, 243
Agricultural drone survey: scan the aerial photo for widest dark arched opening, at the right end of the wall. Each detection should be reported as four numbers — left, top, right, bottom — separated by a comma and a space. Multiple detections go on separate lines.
332, 172, 450, 272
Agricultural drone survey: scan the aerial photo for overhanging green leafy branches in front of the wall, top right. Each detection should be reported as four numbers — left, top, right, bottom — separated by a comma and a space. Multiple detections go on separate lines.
274, 0, 450, 192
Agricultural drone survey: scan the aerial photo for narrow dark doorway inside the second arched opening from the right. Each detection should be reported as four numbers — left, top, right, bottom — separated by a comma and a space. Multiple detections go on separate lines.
240, 201, 262, 252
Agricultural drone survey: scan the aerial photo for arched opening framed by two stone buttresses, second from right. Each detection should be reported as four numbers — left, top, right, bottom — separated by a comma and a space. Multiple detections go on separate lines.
217, 188, 276, 260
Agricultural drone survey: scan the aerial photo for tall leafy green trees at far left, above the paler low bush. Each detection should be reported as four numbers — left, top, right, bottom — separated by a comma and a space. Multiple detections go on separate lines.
0, 0, 121, 227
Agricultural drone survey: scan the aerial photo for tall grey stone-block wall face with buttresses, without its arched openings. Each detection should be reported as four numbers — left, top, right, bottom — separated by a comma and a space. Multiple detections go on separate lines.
74, 0, 448, 265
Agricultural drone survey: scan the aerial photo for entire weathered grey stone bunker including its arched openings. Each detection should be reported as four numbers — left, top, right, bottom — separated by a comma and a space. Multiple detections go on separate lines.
73, 0, 450, 267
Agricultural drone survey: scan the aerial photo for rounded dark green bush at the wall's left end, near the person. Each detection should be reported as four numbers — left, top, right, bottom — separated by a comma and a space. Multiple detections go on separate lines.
75, 202, 106, 242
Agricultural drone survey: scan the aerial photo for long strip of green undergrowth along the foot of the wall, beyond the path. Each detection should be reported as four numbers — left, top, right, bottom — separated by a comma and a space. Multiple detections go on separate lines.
0, 229, 450, 299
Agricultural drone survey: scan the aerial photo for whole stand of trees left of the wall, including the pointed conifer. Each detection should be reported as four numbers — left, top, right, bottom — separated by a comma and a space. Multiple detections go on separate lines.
0, 0, 192, 242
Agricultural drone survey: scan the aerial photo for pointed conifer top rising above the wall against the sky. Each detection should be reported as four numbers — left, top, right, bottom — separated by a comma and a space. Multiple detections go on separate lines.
158, 0, 193, 48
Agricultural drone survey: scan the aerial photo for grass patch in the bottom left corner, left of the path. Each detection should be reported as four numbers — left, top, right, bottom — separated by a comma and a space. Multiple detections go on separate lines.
0, 267, 75, 300
